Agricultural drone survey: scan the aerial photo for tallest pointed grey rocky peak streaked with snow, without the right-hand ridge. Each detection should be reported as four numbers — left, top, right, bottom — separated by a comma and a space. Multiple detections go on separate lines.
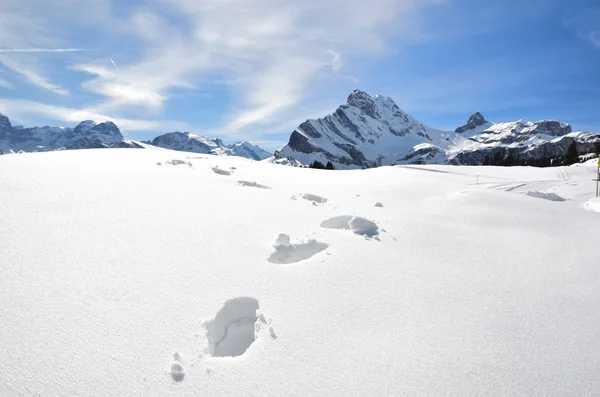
277, 90, 441, 168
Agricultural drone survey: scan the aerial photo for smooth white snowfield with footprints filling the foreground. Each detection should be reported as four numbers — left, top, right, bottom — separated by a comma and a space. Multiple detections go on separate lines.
0, 149, 600, 397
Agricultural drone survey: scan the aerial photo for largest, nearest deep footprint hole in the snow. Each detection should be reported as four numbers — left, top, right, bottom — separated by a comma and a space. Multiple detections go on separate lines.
205, 297, 259, 357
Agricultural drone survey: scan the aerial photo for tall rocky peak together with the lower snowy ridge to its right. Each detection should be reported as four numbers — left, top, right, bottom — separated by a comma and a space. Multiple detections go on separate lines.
274, 90, 600, 169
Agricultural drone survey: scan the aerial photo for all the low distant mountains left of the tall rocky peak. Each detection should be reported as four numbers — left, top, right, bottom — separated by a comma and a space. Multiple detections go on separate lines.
0, 114, 272, 160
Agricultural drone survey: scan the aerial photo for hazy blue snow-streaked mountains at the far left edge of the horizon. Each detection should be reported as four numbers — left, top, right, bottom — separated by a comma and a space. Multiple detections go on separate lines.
0, 115, 143, 153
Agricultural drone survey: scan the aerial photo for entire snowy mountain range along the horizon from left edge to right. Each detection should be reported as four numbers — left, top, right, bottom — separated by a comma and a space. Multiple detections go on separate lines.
0, 90, 600, 169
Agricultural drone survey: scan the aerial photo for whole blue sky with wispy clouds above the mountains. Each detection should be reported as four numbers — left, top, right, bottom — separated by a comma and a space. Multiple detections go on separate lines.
0, 0, 600, 150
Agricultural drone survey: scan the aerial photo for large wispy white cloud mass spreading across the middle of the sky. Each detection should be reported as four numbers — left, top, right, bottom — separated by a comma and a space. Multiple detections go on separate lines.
69, 0, 438, 130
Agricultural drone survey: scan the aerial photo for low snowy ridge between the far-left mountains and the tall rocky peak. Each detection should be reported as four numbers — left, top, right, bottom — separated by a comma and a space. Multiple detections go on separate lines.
151, 132, 272, 160
